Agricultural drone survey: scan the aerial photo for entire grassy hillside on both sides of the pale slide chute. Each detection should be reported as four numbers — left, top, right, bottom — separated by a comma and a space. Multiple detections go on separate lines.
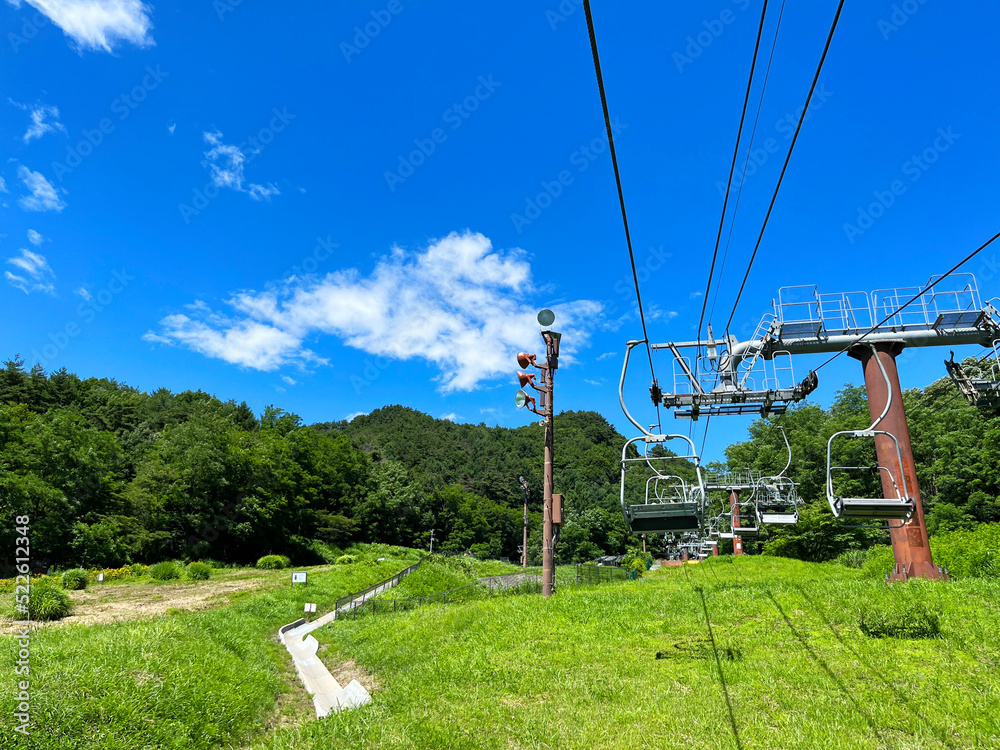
0, 553, 1000, 750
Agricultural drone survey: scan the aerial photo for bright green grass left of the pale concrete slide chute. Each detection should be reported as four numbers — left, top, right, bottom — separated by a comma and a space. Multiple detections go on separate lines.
0, 545, 419, 750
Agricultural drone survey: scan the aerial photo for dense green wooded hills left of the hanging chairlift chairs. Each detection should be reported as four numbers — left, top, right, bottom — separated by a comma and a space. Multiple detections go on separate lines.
0, 358, 627, 568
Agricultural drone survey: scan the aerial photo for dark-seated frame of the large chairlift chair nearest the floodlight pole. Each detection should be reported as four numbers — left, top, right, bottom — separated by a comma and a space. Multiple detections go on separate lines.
621, 430, 705, 534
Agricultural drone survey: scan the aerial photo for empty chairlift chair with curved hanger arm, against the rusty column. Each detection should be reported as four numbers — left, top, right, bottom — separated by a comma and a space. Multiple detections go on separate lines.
826, 346, 916, 523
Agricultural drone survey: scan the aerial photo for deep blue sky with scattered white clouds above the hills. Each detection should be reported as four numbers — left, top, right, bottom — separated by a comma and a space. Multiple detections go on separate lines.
0, 0, 1000, 459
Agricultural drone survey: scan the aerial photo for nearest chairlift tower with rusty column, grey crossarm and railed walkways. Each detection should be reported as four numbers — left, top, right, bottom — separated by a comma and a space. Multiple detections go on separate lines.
619, 274, 1000, 580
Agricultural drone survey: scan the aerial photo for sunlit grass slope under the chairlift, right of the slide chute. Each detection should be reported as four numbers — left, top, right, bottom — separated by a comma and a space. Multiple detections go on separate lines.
255, 558, 1000, 750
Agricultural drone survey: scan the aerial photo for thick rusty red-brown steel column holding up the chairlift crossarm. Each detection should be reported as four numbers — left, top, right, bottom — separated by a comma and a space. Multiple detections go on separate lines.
848, 341, 944, 581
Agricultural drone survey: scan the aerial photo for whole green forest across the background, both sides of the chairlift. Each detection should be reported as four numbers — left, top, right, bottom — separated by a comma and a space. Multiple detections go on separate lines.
0, 357, 1000, 566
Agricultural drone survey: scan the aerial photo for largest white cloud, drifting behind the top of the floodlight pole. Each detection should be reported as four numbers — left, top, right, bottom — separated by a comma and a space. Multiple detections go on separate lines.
146, 232, 602, 393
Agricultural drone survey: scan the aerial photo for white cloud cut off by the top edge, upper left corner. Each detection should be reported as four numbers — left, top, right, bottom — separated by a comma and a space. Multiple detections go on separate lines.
8, 0, 155, 52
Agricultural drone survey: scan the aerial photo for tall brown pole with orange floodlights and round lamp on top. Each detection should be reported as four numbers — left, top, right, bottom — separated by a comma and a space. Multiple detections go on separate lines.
515, 310, 562, 598
